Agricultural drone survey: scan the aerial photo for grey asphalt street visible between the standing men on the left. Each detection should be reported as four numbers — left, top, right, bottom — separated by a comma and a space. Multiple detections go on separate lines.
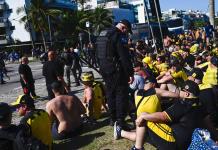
0, 59, 101, 123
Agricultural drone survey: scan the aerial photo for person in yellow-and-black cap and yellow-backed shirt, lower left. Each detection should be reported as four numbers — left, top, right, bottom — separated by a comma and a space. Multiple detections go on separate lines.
11, 95, 52, 149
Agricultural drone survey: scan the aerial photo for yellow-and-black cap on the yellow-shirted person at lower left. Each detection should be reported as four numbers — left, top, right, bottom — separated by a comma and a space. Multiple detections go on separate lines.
11, 95, 35, 108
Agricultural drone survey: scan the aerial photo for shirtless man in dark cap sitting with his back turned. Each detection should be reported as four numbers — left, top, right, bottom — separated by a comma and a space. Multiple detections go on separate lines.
46, 81, 85, 140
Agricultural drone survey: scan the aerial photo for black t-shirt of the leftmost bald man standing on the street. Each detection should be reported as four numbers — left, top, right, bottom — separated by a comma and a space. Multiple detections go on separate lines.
18, 64, 34, 83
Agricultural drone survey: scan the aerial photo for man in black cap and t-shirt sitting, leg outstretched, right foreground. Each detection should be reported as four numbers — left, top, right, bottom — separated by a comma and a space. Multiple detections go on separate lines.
114, 80, 202, 150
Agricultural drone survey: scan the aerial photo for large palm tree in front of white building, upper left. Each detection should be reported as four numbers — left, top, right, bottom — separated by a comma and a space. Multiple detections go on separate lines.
17, 0, 61, 49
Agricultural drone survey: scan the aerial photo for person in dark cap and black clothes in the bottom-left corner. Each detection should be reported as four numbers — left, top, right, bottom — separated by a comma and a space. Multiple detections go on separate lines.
0, 102, 20, 150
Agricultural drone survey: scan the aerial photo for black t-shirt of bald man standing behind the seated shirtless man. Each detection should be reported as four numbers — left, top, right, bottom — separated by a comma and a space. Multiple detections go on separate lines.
42, 61, 63, 85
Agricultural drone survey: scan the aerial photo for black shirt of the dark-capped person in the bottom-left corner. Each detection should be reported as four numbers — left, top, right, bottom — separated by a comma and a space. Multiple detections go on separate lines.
0, 125, 20, 150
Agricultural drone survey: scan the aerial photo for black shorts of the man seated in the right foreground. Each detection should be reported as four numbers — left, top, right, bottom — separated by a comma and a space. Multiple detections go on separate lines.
148, 128, 178, 150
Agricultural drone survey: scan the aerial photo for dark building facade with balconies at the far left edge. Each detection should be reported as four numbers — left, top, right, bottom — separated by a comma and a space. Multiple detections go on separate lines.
0, 0, 15, 45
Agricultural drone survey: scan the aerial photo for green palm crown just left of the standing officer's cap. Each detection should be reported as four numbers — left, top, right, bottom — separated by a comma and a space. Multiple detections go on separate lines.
88, 7, 113, 36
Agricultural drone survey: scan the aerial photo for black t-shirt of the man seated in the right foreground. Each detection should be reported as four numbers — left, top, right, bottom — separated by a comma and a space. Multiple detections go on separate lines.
165, 100, 202, 149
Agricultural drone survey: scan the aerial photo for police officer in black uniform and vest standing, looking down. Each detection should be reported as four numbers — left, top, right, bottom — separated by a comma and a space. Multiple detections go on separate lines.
97, 19, 134, 126
